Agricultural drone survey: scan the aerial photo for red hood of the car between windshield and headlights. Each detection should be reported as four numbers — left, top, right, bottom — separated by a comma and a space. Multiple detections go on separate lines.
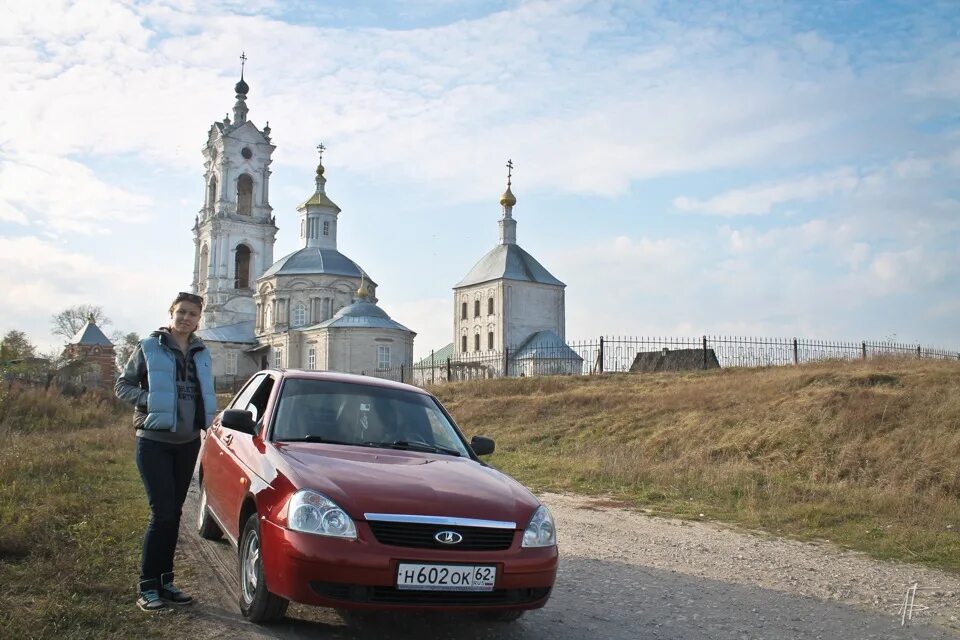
276, 443, 540, 528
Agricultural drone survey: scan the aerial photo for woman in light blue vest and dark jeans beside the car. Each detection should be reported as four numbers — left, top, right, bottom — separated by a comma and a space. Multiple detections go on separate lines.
114, 292, 217, 611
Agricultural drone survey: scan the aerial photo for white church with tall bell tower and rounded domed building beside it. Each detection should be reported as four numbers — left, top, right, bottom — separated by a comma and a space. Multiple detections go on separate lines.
192, 73, 416, 386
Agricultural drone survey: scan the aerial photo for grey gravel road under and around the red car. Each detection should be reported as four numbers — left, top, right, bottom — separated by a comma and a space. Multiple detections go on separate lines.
178, 489, 960, 640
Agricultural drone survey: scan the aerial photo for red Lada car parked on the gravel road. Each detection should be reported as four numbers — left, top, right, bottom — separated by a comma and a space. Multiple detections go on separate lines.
197, 370, 558, 622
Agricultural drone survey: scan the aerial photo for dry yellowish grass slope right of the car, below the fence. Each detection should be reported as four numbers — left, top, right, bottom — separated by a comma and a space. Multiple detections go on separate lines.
433, 360, 960, 571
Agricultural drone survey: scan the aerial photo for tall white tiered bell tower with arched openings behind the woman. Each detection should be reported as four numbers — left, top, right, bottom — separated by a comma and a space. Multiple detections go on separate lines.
192, 55, 277, 329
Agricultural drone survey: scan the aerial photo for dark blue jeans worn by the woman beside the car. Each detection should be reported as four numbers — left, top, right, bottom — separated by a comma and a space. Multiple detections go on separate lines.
137, 438, 200, 581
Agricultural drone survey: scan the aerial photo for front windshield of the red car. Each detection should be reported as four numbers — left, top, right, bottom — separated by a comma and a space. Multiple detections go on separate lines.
273, 378, 468, 457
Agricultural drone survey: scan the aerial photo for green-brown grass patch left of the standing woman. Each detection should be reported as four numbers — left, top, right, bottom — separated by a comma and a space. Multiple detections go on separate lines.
0, 383, 185, 640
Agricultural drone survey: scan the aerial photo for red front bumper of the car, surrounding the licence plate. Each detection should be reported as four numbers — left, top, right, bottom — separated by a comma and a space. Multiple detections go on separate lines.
260, 519, 558, 611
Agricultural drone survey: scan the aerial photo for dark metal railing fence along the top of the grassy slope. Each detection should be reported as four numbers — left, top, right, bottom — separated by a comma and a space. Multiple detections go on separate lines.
408, 336, 960, 386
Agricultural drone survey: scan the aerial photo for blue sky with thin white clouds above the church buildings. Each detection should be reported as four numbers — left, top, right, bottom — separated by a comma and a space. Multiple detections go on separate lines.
0, 0, 960, 358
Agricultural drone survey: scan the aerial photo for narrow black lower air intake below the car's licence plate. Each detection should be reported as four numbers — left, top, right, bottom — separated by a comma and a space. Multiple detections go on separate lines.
310, 582, 550, 607
